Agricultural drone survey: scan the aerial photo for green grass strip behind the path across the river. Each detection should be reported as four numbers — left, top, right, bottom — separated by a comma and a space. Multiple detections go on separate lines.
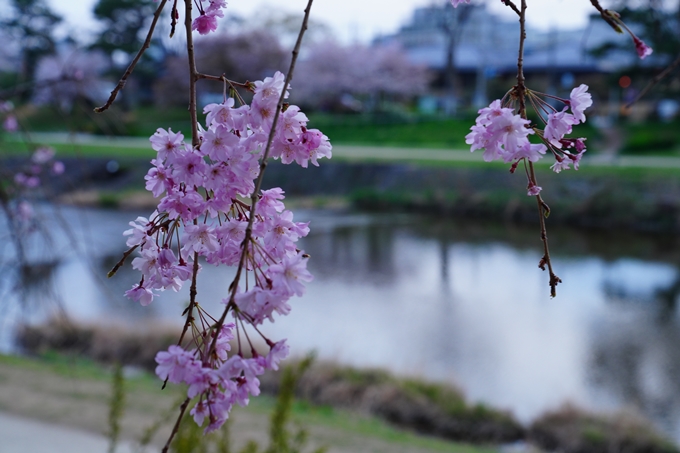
6, 106, 680, 155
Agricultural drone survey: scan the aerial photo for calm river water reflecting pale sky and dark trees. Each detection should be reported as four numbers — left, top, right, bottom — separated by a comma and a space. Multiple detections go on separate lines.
3, 210, 680, 439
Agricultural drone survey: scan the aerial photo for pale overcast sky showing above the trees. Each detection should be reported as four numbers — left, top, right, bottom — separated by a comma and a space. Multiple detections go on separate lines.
48, 0, 610, 42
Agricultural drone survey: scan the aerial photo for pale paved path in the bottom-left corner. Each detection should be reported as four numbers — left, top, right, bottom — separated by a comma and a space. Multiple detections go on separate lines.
0, 412, 132, 453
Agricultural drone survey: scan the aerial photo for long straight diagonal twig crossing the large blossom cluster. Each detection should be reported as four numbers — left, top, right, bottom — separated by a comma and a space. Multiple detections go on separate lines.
208, 0, 314, 356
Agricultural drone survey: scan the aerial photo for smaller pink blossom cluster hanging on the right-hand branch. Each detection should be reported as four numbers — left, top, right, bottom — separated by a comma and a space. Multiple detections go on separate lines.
465, 85, 593, 196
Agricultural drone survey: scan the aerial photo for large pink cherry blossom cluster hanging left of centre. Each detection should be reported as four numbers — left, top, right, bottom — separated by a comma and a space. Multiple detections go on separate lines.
124, 72, 331, 430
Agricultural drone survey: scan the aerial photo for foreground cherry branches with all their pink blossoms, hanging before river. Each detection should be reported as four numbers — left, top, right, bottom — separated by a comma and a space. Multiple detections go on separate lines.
96, 0, 651, 451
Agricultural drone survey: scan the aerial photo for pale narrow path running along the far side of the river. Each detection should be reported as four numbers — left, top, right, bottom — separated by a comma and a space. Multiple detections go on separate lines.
7, 132, 680, 168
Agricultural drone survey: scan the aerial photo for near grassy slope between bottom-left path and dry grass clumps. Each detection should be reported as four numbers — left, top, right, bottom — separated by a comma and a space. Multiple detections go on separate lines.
0, 354, 496, 453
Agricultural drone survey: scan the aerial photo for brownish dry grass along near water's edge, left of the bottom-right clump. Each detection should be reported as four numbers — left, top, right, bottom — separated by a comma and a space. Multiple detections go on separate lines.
19, 320, 525, 443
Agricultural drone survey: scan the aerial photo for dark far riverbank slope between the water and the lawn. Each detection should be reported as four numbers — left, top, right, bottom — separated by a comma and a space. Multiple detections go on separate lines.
13, 148, 680, 232
